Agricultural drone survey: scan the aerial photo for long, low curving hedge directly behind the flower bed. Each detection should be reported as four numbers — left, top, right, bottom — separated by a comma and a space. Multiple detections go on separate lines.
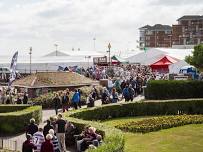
70, 99, 203, 120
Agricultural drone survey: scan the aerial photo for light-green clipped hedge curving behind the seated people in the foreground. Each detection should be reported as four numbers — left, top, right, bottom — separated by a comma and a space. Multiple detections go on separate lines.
66, 116, 124, 152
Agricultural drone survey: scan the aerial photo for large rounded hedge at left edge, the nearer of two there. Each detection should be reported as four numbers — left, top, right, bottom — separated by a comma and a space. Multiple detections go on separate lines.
0, 105, 42, 135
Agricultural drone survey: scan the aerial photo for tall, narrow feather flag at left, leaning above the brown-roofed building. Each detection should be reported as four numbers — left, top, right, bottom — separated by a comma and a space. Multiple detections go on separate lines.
9, 51, 18, 86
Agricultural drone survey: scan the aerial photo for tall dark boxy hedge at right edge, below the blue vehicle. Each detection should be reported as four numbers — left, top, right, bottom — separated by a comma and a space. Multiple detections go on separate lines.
145, 80, 203, 100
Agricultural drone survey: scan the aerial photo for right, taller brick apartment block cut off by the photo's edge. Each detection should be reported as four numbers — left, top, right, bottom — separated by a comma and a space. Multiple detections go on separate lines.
172, 15, 203, 46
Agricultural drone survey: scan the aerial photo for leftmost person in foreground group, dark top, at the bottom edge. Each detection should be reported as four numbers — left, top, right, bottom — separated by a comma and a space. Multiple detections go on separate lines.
22, 134, 37, 152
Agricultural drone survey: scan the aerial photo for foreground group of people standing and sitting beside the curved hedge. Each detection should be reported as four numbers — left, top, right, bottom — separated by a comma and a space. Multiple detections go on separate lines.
22, 114, 102, 152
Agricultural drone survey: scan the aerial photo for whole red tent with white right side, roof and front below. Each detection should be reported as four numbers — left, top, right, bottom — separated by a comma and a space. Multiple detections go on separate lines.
150, 55, 179, 73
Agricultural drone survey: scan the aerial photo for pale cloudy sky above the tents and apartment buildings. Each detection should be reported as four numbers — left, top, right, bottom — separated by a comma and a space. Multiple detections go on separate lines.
0, 0, 203, 56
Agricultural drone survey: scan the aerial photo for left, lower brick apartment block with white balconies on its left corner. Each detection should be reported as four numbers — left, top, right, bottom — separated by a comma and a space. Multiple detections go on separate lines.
139, 24, 172, 49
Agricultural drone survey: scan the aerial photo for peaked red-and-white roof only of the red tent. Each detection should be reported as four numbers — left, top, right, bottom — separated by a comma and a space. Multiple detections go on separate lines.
151, 55, 179, 66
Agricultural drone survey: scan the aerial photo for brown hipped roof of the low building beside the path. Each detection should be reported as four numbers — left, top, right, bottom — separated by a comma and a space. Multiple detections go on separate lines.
12, 72, 96, 88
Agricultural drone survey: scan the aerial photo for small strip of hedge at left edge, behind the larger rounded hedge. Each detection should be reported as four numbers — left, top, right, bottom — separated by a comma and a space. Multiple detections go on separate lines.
0, 105, 29, 113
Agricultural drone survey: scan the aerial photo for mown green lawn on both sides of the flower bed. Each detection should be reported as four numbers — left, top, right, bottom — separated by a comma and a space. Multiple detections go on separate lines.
103, 117, 203, 152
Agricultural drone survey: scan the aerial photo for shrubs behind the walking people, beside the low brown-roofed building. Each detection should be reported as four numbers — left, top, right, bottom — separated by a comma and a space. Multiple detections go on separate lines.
32, 86, 102, 109
